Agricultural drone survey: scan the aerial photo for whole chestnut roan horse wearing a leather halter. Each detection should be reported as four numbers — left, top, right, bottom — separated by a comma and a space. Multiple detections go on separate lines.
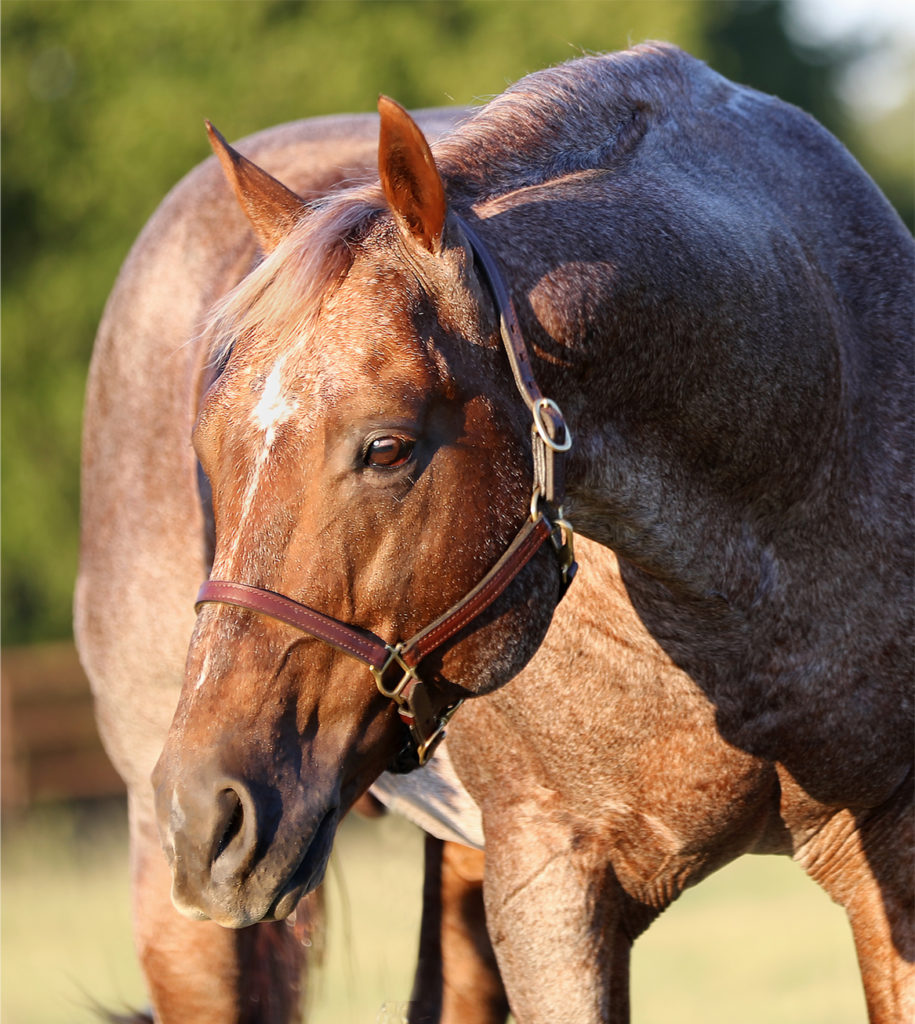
77, 44, 915, 1022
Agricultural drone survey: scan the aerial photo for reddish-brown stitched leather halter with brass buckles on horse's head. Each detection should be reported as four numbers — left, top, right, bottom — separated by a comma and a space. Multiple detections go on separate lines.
197, 220, 577, 771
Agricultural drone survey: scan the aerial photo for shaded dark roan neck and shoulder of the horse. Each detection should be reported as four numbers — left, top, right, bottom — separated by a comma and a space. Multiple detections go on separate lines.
443, 53, 912, 806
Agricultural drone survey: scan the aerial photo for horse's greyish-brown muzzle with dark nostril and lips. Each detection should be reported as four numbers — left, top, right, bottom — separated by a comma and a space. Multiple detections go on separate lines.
153, 758, 340, 928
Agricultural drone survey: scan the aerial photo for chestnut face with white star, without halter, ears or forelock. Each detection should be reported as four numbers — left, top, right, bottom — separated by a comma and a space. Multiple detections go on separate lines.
154, 232, 558, 927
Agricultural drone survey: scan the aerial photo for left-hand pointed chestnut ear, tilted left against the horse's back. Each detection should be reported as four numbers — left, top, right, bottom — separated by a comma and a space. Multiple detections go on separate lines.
207, 121, 308, 252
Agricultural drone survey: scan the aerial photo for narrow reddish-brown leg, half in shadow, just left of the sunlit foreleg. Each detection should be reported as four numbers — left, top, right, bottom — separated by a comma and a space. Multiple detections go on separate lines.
408, 835, 509, 1024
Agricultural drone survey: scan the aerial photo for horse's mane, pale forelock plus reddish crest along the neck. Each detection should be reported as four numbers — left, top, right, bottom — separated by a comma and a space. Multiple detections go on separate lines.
205, 43, 704, 366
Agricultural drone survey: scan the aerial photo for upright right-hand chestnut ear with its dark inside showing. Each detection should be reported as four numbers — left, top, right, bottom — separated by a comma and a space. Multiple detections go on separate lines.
378, 96, 447, 255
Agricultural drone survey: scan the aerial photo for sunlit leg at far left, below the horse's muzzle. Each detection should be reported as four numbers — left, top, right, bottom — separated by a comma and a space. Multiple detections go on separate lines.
131, 802, 315, 1024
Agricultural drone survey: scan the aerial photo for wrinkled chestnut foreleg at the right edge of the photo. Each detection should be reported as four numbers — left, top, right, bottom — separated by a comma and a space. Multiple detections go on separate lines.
795, 773, 915, 1024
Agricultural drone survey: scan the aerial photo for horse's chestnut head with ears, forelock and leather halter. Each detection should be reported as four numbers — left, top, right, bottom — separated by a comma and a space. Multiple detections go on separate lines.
154, 98, 564, 927
